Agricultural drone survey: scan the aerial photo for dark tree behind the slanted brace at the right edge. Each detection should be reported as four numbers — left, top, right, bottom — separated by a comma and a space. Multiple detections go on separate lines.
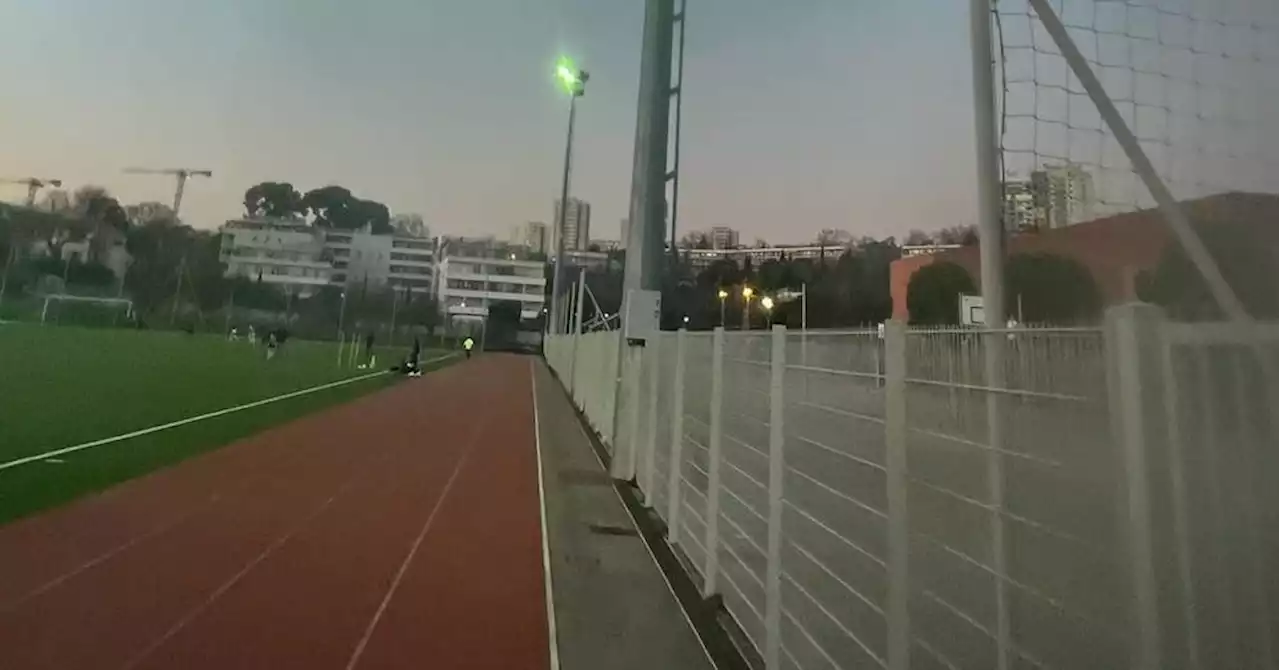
1137, 218, 1280, 322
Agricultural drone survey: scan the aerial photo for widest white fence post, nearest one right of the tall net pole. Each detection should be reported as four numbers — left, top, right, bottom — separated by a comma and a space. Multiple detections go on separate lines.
1106, 305, 1161, 670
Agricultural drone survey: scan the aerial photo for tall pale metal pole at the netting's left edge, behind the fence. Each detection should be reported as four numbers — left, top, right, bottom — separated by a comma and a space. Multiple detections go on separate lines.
969, 0, 1012, 670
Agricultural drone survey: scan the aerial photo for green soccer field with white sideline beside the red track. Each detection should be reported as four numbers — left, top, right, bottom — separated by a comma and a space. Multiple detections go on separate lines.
0, 324, 453, 523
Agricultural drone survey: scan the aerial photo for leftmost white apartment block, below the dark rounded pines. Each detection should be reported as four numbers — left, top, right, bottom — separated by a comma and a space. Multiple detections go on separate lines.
220, 219, 334, 297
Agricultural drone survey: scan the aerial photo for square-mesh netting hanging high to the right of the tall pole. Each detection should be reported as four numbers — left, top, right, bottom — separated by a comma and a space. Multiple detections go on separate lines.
996, 0, 1280, 229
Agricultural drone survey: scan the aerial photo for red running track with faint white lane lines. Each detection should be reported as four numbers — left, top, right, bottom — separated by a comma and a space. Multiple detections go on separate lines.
0, 356, 549, 670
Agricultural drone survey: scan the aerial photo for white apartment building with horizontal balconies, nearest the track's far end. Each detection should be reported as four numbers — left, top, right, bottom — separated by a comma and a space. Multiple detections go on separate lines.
435, 256, 547, 324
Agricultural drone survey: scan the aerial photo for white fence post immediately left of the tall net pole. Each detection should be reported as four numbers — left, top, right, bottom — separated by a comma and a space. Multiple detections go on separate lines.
876, 320, 911, 670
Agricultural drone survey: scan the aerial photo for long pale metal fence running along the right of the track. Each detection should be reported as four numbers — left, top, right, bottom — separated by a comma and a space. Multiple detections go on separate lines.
547, 312, 1280, 670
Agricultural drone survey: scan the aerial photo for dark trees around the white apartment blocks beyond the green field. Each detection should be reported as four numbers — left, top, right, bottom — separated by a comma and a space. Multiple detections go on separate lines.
0, 182, 438, 337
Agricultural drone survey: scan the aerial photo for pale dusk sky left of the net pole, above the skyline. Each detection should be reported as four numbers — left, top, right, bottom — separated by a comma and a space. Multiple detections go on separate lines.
0, 0, 974, 241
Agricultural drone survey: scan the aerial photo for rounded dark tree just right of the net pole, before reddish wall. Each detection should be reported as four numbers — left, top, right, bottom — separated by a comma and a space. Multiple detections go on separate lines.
1005, 254, 1102, 324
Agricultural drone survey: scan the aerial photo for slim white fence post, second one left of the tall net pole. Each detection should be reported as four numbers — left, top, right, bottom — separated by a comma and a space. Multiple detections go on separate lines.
764, 325, 787, 670
